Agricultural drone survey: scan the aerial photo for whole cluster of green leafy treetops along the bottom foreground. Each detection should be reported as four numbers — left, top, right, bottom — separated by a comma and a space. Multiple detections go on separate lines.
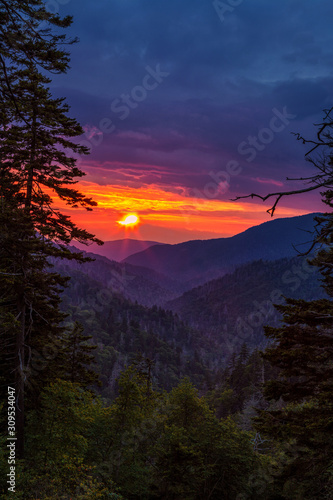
0, 357, 274, 500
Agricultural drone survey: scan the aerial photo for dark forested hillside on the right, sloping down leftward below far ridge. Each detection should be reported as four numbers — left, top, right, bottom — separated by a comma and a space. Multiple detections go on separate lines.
166, 256, 327, 356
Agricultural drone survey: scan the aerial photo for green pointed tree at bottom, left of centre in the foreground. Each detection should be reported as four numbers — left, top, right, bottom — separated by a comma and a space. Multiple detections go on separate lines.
88, 366, 163, 498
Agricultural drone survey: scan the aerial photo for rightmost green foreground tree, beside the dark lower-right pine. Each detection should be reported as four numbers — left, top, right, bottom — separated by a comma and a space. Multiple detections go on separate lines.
155, 380, 258, 499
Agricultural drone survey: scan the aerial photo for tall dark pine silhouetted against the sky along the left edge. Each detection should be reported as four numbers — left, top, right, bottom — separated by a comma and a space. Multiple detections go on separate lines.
0, 0, 101, 457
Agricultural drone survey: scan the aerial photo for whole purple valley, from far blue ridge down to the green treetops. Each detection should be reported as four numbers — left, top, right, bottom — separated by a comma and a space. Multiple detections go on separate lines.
55, 215, 326, 397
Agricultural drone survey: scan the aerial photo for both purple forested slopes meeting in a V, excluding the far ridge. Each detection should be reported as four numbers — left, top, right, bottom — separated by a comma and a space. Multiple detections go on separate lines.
50, 248, 326, 397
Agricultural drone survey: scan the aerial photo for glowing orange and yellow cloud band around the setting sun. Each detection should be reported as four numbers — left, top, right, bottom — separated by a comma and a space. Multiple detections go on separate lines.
50, 181, 308, 243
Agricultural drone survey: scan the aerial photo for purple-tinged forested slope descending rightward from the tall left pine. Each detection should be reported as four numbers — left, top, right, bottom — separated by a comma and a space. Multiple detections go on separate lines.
58, 271, 216, 397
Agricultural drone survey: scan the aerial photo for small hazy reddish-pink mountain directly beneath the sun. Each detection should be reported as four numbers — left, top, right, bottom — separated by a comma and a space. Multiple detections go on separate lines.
75, 239, 162, 262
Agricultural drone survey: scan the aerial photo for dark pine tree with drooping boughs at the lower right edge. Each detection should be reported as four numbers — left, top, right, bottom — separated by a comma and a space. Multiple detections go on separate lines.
256, 299, 333, 499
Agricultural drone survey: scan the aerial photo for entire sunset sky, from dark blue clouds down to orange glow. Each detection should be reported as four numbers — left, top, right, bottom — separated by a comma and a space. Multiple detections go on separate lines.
49, 0, 333, 243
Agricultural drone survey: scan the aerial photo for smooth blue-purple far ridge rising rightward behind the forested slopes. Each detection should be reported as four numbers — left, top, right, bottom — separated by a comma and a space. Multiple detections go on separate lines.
124, 214, 319, 289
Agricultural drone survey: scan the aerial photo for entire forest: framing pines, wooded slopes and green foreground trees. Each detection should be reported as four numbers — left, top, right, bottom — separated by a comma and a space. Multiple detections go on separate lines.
0, 0, 333, 500
